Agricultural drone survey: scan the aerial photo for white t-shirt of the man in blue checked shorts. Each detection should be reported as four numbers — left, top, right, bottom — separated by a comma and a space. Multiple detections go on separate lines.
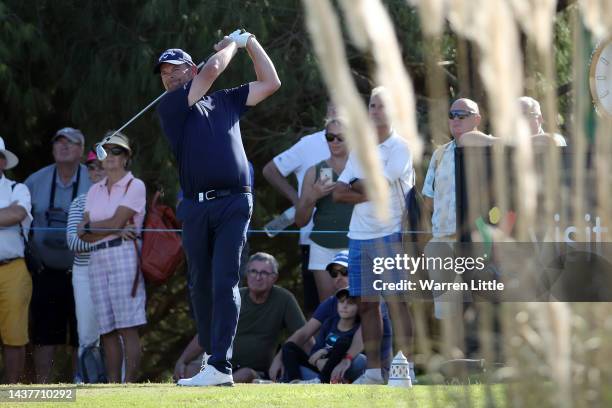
338, 131, 414, 239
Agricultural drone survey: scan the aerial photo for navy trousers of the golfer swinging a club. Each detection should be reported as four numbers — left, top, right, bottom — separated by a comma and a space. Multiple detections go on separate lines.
178, 193, 253, 374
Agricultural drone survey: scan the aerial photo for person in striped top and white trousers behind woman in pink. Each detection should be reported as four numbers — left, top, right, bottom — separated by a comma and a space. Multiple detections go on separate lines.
66, 151, 105, 382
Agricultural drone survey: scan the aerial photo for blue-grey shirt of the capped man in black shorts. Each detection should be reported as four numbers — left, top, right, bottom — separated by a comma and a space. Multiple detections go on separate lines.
25, 164, 91, 269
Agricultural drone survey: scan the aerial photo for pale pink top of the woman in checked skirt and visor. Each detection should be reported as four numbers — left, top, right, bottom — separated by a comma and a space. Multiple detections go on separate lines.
85, 172, 147, 242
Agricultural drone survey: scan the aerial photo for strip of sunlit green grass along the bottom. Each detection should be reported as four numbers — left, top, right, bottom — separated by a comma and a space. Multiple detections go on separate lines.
0, 384, 503, 408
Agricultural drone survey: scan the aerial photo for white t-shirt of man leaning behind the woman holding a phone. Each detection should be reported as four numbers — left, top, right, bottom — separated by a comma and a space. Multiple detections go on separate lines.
273, 130, 330, 245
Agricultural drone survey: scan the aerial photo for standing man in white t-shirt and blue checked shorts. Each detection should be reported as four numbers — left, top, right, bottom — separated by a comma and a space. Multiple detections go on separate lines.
333, 87, 414, 384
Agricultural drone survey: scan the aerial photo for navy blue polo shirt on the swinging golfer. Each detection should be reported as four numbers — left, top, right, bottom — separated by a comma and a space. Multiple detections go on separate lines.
157, 81, 251, 197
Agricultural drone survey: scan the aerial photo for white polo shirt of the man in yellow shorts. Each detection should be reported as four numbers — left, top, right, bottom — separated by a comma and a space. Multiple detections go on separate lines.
0, 175, 32, 260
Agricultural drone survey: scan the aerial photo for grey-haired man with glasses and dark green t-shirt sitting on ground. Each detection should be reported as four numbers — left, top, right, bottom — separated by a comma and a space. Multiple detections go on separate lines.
174, 252, 306, 385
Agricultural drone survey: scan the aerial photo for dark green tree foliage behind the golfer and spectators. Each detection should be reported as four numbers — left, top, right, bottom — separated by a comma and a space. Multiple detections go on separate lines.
0, 0, 566, 380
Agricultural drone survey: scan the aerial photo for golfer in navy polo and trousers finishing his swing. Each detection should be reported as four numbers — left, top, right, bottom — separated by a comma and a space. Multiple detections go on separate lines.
155, 31, 280, 386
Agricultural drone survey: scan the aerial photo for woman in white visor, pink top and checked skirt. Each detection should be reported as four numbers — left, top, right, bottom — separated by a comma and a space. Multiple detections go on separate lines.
79, 133, 146, 382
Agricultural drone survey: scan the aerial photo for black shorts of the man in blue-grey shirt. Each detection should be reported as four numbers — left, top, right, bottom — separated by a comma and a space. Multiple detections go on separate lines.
30, 268, 78, 347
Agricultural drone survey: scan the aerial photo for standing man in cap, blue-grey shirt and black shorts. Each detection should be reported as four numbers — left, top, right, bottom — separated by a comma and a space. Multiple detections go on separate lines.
25, 127, 91, 384
